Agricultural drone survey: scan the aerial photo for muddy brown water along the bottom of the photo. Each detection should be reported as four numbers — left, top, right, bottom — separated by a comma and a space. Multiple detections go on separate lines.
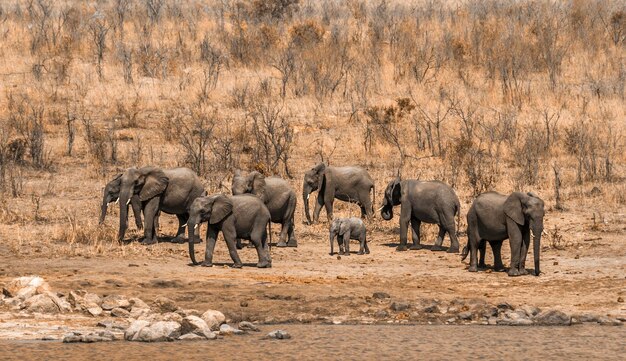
0, 325, 626, 361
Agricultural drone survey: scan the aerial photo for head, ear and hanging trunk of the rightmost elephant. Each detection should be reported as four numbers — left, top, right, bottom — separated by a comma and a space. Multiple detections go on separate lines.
504, 192, 545, 276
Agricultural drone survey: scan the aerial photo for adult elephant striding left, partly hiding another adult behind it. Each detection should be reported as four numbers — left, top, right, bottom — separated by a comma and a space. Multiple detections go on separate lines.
187, 194, 272, 268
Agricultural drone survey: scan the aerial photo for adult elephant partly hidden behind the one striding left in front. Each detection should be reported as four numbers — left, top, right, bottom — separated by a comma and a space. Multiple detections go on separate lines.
232, 170, 298, 248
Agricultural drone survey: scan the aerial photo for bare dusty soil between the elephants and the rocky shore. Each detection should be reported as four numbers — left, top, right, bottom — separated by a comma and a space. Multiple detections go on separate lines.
0, 205, 626, 323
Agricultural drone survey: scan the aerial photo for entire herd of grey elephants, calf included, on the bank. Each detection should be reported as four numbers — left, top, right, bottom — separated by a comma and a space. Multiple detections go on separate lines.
100, 163, 544, 276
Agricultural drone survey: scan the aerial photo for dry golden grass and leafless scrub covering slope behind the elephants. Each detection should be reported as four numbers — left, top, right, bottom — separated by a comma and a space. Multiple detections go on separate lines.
0, 0, 626, 256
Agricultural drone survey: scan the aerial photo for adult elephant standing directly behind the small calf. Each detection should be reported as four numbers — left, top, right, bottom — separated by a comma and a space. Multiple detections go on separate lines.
302, 163, 375, 224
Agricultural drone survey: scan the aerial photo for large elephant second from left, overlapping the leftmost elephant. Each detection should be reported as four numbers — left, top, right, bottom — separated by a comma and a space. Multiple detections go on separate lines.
118, 167, 205, 244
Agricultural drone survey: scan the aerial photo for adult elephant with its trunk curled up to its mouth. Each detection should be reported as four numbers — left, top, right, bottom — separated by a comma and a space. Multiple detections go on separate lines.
380, 177, 461, 253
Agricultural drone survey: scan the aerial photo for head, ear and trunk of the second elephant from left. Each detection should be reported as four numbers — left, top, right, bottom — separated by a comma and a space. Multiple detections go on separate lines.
118, 167, 169, 240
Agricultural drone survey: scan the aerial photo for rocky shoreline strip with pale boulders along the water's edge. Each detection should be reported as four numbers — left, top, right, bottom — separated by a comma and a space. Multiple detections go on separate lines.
0, 276, 626, 343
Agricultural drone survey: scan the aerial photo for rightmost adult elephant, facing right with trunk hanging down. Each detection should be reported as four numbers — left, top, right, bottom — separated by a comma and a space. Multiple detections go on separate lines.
462, 192, 545, 276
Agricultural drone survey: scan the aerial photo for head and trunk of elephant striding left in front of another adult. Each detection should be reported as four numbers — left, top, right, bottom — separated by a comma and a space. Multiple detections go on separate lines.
187, 194, 233, 265
